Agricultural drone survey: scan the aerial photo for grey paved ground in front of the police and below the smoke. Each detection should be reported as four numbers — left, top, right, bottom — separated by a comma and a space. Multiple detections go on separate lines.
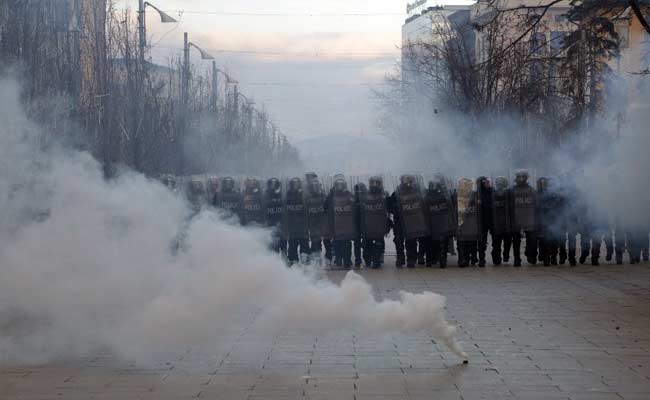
0, 264, 650, 400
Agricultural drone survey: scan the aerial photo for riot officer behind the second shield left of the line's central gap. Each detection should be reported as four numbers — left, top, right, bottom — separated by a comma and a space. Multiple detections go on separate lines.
327, 175, 358, 269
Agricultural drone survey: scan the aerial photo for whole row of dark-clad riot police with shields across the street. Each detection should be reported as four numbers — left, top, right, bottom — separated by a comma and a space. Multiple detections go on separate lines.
161, 170, 648, 268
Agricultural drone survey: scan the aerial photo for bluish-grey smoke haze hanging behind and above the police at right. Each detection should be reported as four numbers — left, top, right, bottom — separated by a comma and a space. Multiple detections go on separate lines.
373, 65, 650, 233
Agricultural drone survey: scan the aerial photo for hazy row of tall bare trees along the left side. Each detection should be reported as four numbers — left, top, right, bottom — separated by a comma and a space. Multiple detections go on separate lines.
0, 0, 301, 177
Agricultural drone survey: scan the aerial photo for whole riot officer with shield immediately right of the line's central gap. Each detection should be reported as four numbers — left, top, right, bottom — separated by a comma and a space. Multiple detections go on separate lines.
389, 175, 431, 268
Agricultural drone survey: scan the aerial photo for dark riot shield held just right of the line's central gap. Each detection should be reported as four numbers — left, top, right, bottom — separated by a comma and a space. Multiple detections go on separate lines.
395, 179, 431, 239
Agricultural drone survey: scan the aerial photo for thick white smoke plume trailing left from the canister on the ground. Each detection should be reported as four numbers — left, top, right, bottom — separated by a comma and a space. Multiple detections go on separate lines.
0, 76, 467, 362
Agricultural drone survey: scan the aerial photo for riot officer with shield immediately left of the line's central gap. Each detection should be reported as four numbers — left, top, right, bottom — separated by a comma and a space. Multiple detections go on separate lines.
359, 176, 390, 269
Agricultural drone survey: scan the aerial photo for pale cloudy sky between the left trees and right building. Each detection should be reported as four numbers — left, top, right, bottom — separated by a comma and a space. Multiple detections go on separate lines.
123, 0, 466, 142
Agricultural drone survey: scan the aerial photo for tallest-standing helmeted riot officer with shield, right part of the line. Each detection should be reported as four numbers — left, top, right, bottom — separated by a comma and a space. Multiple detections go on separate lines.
512, 170, 537, 267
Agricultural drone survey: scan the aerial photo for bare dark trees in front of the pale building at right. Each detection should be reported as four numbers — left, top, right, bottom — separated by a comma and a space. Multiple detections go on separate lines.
377, 0, 650, 164
